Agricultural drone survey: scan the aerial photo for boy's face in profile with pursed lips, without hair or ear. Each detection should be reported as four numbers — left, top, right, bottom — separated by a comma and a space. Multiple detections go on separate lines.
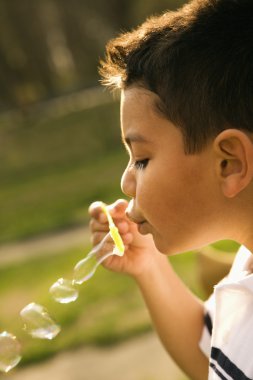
121, 87, 225, 254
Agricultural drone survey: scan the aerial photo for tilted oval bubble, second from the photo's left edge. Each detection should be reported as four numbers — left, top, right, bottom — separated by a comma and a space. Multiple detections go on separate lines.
20, 303, 60, 340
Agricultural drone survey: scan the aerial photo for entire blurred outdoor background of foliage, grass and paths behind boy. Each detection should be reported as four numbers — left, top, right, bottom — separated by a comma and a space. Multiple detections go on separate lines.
0, 0, 235, 380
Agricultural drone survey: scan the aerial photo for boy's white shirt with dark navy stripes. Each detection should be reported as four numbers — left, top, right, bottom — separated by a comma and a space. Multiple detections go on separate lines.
200, 246, 253, 380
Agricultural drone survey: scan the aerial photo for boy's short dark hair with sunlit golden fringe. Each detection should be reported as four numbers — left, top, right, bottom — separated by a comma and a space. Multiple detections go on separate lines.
100, 0, 253, 153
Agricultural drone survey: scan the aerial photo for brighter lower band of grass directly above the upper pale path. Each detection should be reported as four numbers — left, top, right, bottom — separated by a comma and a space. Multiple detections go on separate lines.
0, 152, 125, 241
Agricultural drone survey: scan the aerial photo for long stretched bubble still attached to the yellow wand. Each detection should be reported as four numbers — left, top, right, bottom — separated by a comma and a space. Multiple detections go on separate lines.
73, 233, 122, 285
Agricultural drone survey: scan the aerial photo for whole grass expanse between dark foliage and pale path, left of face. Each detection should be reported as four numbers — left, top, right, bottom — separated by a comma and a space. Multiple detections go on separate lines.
0, 102, 127, 243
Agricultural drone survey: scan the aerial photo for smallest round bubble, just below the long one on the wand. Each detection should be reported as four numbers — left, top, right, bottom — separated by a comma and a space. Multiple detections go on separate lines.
49, 278, 78, 303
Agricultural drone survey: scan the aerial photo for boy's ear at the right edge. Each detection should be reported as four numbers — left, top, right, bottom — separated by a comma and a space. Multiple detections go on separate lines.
213, 129, 253, 198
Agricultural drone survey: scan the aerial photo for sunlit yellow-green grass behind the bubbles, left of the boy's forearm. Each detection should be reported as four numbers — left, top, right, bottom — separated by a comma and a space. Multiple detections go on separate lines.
0, 246, 151, 364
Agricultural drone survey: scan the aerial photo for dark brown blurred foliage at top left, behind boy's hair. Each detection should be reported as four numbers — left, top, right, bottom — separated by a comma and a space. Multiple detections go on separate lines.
0, 0, 185, 112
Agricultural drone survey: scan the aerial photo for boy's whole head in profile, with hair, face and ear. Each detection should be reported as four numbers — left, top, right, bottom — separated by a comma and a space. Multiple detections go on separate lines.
101, 0, 253, 253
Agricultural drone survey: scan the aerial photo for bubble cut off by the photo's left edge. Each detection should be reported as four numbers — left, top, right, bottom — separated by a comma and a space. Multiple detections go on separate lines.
0, 331, 21, 373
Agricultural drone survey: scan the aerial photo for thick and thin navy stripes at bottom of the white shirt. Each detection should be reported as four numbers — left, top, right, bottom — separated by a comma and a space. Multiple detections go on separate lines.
210, 347, 252, 380
